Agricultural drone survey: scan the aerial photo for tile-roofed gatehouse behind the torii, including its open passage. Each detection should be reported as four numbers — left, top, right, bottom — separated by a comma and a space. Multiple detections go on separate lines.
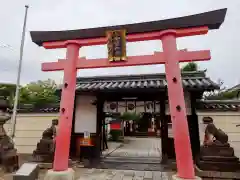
65, 71, 218, 169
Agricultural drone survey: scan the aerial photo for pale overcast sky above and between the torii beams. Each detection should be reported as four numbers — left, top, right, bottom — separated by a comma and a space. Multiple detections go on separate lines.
0, 0, 240, 86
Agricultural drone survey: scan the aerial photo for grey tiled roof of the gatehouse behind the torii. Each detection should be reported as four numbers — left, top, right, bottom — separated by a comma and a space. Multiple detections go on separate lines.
76, 71, 219, 91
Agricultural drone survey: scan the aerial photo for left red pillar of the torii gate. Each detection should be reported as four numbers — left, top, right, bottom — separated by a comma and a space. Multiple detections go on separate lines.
53, 44, 79, 171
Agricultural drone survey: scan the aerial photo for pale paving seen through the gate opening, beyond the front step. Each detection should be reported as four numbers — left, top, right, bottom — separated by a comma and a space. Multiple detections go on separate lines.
110, 137, 161, 157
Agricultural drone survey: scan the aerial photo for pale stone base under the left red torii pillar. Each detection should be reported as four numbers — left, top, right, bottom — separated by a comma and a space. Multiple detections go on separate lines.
44, 168, 74, 180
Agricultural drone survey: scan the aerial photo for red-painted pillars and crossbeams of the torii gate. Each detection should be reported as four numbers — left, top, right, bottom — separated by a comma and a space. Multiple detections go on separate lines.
32, 9, 226, 179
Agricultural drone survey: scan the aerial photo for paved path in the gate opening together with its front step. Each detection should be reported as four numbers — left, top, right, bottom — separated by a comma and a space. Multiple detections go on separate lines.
98, 137, 164, 172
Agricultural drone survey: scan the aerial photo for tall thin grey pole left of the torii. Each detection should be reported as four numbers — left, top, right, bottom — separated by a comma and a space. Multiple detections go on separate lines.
11, 5, 29, 138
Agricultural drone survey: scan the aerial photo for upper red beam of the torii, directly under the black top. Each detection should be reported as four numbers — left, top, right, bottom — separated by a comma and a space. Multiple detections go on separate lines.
43, 27, 208, 49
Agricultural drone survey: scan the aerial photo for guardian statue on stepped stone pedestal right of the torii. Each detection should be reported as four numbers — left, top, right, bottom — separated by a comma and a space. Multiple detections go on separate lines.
197, 121, 240, 172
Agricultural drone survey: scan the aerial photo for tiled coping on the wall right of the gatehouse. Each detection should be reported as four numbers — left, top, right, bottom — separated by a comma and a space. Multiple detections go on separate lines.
197, 100, 240, 111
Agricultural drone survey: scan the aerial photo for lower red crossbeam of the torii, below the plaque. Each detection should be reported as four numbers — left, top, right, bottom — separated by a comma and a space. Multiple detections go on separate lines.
42, 51, 211, 71
